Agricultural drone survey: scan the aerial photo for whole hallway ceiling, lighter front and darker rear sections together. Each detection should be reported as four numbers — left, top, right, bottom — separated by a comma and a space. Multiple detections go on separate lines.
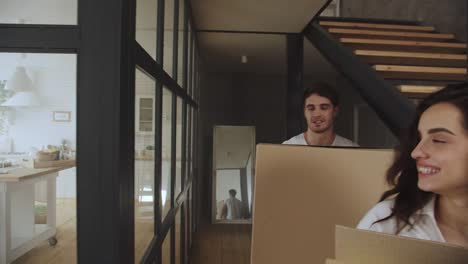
191, 0, 330, 75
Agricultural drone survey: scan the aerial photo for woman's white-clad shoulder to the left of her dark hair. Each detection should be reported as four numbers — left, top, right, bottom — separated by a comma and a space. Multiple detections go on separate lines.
357, 199, 395, 233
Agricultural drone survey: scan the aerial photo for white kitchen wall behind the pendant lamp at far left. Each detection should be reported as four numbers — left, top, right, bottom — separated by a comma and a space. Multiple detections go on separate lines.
0, 53, 76, 152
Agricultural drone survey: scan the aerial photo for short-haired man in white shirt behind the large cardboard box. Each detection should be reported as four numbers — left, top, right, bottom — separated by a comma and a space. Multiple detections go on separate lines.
283, 83, 358, 147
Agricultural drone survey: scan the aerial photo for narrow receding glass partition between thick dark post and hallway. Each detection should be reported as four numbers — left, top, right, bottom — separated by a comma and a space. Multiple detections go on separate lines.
135, 0, 199, 264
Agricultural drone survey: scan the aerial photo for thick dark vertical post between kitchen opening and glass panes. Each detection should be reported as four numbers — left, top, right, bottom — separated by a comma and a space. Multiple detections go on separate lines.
77, 0, 136, 264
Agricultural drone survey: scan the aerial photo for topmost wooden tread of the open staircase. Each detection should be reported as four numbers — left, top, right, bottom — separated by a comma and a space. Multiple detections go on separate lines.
319, 21, 435, 32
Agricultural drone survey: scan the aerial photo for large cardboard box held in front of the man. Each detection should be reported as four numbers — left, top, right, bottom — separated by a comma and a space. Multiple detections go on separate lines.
251, 144, 394, 264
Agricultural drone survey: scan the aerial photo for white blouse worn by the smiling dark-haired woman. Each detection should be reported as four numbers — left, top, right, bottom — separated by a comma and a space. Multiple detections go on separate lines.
357, 196, 445, 242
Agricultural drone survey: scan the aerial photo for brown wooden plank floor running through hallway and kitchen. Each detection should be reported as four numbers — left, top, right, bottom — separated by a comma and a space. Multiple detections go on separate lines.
13, 199, 252, 264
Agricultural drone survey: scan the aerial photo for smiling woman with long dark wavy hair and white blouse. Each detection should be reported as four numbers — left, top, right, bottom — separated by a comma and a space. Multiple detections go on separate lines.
358, 83, 468, 248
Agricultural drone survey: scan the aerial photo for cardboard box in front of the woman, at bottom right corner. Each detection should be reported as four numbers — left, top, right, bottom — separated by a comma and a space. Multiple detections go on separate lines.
335, 226, 468, 264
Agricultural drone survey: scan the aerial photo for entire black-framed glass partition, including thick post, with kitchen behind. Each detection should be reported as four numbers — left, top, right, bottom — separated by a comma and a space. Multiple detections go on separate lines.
0, 0, 199, 264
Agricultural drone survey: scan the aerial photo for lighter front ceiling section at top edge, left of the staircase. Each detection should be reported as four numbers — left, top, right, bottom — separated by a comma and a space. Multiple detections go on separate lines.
191, 0, 327, 33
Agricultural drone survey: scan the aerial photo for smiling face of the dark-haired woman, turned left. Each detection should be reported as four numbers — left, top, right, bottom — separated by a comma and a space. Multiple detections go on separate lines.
411, 103, 468, 196
